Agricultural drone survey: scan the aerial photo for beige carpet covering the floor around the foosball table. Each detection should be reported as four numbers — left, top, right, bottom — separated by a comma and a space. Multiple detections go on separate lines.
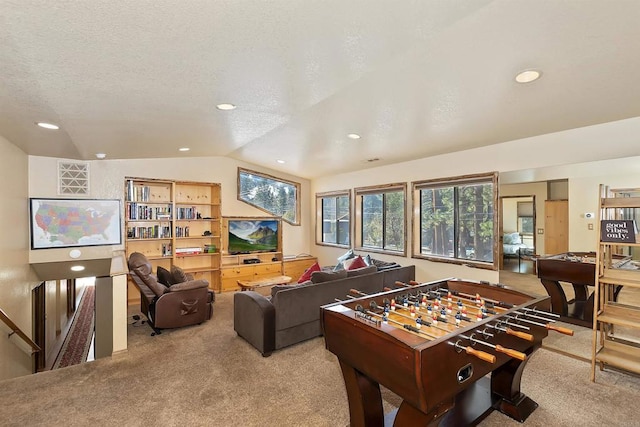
0, 282, 640, 427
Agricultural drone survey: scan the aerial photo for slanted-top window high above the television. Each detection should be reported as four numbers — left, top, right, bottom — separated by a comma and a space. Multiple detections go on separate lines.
238, 168, 300, 225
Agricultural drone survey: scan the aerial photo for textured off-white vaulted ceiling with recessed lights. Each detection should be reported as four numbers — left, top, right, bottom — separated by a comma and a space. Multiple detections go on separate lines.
0, 0, 640, 178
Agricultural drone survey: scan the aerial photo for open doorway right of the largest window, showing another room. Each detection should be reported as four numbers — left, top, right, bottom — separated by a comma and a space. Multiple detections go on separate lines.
500, 194, 536, 274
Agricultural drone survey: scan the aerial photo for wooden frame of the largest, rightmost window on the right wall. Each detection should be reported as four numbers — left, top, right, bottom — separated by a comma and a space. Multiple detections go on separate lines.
411, 172, 500, 270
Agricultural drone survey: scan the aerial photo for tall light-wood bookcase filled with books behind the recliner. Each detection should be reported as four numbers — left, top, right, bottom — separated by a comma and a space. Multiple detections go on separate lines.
125, 177, 222, 304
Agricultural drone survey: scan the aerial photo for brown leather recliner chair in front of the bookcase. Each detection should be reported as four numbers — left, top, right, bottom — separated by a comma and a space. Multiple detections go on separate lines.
128, 252, 215, 335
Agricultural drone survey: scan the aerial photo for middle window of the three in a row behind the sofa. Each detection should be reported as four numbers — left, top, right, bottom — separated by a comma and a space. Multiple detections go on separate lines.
355, 183, 407, 255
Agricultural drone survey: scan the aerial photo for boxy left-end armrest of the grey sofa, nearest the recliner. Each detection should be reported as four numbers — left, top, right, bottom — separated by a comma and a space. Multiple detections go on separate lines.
233, 291, 276, 357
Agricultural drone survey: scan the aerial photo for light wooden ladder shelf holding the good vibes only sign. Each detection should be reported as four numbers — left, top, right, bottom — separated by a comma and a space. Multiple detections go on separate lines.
591, 185, 640, 381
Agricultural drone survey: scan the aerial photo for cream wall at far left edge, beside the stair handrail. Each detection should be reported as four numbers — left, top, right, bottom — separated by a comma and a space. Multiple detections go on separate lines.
0, 137, 38, 380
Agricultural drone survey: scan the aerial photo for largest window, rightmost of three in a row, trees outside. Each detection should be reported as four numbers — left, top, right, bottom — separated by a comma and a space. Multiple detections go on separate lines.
413, 173, 498, 268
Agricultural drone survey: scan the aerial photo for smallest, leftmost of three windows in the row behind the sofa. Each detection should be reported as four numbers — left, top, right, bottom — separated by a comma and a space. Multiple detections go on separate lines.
316, 190, 351, 247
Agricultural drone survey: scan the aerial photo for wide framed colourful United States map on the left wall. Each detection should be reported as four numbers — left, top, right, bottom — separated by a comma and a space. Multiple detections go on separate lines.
29, 198, 122, 249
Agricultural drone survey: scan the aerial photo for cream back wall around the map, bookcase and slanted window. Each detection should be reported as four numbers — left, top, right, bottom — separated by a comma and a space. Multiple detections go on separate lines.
29, 156, 312, 262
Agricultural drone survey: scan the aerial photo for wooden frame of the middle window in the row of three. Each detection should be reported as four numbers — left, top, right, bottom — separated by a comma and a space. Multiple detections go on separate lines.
353, 182, 409, 257
